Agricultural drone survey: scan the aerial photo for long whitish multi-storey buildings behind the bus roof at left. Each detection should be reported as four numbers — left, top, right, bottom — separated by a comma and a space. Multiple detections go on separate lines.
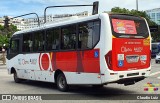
0, 11, 89, 30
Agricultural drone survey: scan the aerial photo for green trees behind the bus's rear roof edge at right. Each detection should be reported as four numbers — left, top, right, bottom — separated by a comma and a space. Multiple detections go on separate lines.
111, 7, 160, 42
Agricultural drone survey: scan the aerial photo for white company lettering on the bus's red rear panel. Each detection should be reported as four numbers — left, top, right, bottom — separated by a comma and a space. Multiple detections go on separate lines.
121, 46, 143, 53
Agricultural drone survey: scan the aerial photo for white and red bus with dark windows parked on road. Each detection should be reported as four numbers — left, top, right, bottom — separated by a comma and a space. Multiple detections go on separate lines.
7, 13, 151, 91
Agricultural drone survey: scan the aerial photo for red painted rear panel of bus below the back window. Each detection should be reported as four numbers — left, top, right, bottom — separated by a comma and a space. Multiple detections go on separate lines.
112, 38, 150, 71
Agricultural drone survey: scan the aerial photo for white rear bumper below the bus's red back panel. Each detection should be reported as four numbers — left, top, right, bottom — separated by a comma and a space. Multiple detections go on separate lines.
102, 68, 151, 84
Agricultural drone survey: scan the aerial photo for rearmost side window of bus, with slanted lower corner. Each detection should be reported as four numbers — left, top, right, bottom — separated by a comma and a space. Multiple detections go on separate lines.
78, 21, 100, 50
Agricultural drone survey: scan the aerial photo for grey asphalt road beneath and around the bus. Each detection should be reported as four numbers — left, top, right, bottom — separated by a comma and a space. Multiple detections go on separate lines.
0, 59, 160, 103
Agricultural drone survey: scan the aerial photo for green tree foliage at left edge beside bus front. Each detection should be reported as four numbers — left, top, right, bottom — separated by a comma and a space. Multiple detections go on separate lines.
0, 25, 18, 47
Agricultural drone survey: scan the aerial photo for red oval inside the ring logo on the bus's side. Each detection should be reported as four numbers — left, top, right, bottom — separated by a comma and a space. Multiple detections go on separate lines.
41, 54, 49, 70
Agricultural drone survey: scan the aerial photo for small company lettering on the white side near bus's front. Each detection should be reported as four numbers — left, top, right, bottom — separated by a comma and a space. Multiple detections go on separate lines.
18, 59, 37, 65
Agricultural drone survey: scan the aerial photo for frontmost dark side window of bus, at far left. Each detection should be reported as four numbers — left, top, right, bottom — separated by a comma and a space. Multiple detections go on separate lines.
10, 39, 19, 54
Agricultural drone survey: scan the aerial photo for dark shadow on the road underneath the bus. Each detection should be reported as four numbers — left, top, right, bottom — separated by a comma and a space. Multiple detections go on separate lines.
7, 80, 135, 99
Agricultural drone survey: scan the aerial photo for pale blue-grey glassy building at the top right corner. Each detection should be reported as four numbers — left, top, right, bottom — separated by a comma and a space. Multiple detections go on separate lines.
145, 8, 160, 25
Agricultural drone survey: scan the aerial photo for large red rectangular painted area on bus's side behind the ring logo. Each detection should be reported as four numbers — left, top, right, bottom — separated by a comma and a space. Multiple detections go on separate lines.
47, 49, 100, 73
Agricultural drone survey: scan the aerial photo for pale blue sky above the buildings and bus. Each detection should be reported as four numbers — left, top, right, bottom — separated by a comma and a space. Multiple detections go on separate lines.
0, 0, 160, 17
